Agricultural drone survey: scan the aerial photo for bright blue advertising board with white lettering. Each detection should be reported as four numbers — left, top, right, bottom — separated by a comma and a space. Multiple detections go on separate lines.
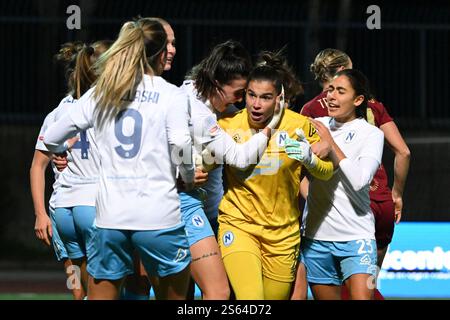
377, 222, 450, 298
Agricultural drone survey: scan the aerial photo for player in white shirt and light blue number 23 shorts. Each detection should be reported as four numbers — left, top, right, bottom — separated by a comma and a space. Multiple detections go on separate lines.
286, 69, 384, 299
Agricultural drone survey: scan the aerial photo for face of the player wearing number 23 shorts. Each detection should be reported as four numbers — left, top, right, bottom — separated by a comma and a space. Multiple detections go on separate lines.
327, 75, 364, 122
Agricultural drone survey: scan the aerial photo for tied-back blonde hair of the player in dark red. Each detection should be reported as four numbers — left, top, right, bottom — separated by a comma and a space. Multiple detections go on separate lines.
309, 48, 351, 83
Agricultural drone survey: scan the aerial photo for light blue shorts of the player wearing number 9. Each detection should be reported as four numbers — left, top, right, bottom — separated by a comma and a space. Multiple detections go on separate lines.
87, 223, 191, 280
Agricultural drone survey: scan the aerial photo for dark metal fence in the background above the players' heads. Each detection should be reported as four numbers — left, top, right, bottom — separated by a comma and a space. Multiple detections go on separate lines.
0, 0, 450, 130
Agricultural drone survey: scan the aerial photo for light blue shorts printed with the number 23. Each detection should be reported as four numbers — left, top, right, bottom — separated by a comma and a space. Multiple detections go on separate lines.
301, 238, 377, 286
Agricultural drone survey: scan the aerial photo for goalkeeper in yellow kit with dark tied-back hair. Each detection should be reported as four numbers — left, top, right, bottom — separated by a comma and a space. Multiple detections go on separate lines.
219, 52, 333, 300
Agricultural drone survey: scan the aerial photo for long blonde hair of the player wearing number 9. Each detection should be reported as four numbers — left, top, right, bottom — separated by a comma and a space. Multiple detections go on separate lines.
93, 18, 167, 123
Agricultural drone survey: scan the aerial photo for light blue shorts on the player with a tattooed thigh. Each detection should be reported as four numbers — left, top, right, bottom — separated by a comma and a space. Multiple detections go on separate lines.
180, 189, 215, 246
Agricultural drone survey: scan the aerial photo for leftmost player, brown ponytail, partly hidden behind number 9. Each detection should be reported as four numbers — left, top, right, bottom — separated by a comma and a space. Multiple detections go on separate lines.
30, 41, 110, 300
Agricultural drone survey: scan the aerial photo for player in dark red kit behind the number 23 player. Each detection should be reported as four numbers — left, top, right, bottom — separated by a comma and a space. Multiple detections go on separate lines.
293, 49, 410, 299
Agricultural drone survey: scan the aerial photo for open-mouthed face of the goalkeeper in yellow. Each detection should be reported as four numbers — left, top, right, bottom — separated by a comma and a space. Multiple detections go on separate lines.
245, 80, 277, 129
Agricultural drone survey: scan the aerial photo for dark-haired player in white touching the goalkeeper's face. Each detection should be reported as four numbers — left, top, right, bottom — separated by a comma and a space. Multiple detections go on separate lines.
180, 41, 282, 299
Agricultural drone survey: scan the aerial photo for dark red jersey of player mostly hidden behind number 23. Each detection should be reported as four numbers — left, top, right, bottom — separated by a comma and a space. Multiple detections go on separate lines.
300, 91, 393, 201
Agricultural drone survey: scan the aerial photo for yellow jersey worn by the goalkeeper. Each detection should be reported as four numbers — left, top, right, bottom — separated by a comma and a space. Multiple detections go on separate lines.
219, 109, 333, 227
